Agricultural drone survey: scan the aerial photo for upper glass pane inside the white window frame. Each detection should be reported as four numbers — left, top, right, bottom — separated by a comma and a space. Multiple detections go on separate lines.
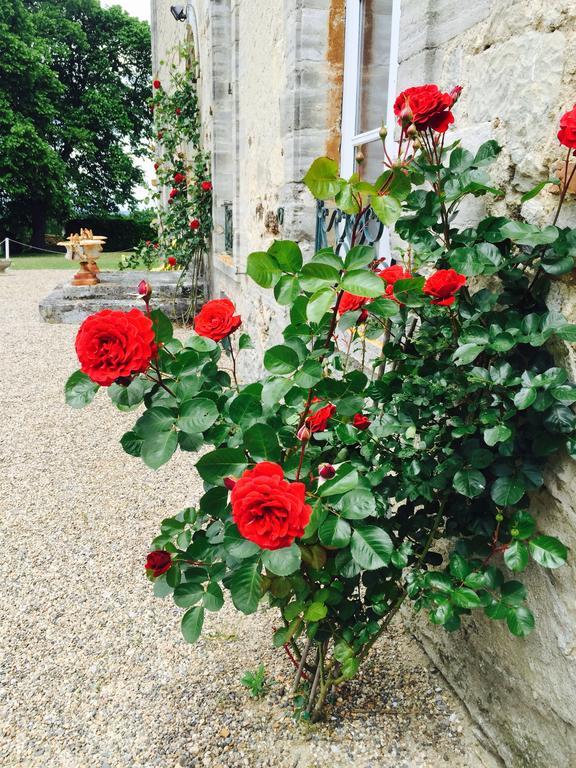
357, 0, 392, 133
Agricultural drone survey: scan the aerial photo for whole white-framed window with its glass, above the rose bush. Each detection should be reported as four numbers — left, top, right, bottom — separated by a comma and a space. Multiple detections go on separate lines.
341, 0, 400, 181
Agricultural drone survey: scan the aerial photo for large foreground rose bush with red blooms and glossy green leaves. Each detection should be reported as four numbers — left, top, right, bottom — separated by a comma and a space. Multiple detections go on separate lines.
66, 85, 576, 719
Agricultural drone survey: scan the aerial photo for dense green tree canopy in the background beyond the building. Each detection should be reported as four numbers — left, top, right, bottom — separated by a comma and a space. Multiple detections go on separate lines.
0, 0, 151, 243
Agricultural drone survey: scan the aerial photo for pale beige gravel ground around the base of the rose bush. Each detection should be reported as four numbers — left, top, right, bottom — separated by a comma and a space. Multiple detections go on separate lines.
0, 271, 495, 768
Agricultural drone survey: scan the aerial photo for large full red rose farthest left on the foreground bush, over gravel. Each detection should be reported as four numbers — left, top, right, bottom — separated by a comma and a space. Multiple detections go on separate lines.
76, 309, 157, 387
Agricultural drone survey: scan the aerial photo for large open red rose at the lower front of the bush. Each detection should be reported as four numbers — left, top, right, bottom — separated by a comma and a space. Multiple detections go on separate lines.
230, 461, 312, 549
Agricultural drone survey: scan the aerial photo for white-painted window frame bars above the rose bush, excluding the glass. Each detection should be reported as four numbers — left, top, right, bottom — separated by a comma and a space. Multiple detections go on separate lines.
340, 0, 401, 178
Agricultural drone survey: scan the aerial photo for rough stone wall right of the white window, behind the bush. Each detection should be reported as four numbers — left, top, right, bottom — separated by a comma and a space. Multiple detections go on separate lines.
399, 0, 576, 768
